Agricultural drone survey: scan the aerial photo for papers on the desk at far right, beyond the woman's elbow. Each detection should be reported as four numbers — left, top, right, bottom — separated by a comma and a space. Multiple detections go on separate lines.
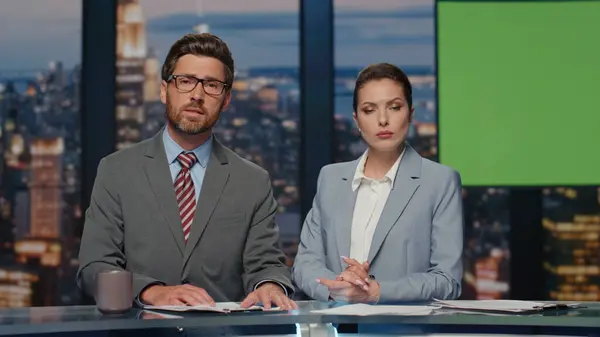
435, 300, 578, 313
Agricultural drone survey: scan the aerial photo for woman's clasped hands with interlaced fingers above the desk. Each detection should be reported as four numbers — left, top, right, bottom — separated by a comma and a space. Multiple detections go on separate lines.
317, 279, 379, 303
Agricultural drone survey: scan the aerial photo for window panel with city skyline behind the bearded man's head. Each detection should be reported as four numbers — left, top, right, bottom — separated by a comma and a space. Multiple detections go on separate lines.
115, 0, 301, 264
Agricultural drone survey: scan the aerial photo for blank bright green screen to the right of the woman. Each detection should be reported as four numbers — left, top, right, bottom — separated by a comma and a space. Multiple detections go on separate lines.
437, 1, 600, 186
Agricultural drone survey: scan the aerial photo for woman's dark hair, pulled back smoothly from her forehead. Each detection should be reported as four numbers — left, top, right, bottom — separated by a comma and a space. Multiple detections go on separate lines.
352, 63, 412, 111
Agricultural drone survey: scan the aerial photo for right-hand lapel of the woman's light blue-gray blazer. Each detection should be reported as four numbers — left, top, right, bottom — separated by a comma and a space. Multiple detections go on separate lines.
369, 144, 422, 263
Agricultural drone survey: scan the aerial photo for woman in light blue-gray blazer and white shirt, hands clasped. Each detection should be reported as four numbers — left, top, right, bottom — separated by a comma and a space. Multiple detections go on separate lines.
293, 63, 463, 303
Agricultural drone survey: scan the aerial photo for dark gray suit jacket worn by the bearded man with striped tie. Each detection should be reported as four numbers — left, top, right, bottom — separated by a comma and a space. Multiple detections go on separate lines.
77, 133, 293, 301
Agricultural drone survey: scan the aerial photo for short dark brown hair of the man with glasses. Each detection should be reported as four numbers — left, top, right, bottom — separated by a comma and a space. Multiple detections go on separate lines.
161, 33, 234, 88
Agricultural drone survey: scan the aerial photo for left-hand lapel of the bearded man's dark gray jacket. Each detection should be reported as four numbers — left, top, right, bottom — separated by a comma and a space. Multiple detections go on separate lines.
143, 132, 185, 255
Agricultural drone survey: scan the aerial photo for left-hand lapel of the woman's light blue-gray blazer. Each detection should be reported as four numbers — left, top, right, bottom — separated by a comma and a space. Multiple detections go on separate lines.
334, 160, 359, 270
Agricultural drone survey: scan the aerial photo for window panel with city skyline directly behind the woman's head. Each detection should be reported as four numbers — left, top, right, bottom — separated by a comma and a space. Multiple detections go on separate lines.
334, 0, 437, 162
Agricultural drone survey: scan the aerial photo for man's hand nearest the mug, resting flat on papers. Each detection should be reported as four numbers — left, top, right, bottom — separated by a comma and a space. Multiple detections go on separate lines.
140, 284, 215, 306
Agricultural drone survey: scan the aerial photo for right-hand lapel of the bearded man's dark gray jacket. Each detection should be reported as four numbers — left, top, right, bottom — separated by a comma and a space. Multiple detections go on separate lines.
183, 135, 230, 267
